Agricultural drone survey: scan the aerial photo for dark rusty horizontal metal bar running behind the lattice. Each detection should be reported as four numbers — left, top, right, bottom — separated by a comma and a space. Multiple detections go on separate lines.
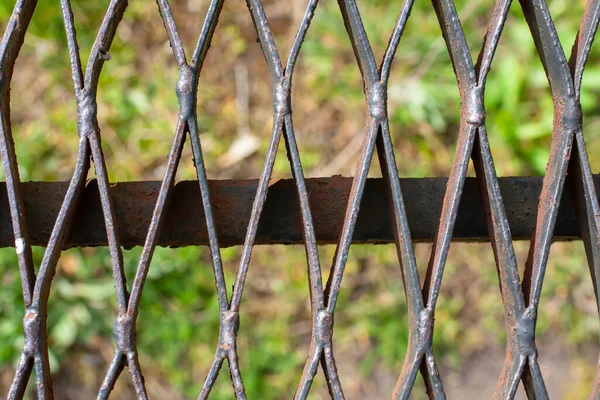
0, 176, 600, 248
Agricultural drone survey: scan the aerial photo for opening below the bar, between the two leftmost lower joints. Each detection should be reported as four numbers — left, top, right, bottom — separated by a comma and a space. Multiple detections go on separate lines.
50, 248, 130, 398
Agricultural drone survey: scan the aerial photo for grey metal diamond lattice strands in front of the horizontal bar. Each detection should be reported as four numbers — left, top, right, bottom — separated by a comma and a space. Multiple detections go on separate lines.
0, 0, 600, 399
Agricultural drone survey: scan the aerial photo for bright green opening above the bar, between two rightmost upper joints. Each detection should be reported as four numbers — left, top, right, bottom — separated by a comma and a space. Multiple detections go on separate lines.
485, 4, 581, 175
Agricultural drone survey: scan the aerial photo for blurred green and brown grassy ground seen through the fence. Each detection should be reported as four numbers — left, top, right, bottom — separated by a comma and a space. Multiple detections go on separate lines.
0, 0, 600, 399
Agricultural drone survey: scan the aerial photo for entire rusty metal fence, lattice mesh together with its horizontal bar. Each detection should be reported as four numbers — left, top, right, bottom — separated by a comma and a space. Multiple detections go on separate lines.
0, 0, 600, 399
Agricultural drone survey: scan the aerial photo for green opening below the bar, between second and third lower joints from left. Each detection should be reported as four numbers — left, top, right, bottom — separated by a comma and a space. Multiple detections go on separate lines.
134, 247, 239, 398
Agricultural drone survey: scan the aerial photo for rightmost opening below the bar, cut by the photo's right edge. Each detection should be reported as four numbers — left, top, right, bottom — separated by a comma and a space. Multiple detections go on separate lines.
536, 242, 600, 398
